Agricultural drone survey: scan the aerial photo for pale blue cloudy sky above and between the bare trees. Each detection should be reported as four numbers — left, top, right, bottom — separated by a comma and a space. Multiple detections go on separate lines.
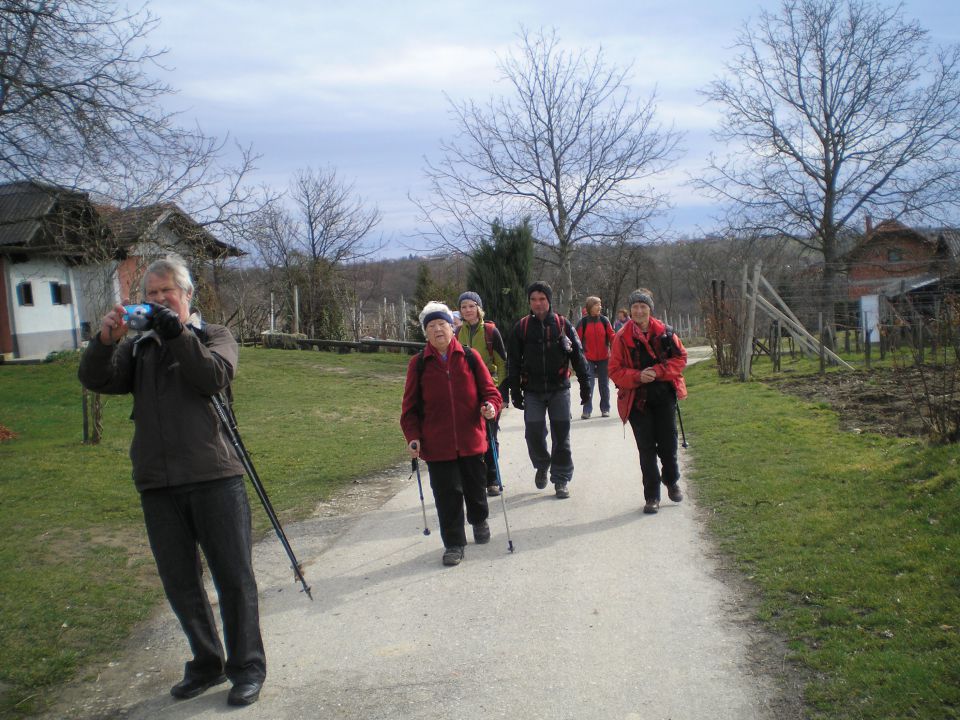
148, 0, 960, 255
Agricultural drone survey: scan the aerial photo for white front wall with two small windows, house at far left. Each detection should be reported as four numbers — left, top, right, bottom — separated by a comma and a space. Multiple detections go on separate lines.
4, 258, 80, 359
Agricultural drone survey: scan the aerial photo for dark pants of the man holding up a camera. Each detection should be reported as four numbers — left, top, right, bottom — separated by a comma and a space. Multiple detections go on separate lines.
140, 477, 267, 683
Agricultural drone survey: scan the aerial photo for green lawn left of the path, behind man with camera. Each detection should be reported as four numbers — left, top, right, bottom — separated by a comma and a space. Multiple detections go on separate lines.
0, 349, 408, 717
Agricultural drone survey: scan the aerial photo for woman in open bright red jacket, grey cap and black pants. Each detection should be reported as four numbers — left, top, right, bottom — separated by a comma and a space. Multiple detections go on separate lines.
610, 288, 687, 515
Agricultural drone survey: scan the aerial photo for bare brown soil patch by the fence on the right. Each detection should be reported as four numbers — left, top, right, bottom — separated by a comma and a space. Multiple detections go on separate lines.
764, 367, 960, 437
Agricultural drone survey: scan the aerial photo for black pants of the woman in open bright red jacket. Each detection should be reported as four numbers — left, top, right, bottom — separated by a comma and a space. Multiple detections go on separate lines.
630, 398, 680, 500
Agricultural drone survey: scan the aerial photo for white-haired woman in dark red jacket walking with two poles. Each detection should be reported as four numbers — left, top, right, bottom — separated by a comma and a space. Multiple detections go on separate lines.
400, 302, 501, 565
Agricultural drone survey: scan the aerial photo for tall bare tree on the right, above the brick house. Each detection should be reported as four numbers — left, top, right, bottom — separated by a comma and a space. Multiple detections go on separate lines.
694, 0, 960, 346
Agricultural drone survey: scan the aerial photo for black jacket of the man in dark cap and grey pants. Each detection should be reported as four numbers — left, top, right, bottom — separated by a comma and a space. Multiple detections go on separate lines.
507, 310, 589, 396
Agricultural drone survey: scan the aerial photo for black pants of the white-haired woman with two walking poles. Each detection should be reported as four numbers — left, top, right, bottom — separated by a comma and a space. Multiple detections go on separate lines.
427, 455, 490, 547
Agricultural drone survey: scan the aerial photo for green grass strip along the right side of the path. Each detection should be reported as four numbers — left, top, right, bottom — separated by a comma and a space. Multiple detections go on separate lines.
683, 361, 960, 720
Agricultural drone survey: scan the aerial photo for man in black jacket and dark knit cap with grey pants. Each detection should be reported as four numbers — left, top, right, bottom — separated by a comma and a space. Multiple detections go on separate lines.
507, 280, 590, 499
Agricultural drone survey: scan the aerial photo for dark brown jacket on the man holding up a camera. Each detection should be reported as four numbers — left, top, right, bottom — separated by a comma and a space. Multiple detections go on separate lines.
78, 325, 244, 492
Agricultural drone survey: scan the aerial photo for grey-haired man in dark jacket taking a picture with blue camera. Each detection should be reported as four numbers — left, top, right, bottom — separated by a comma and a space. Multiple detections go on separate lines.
79, 259, 266, 705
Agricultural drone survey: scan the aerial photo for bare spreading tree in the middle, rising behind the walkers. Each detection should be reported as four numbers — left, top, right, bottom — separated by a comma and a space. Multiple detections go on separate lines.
417, 30, 679, 316
